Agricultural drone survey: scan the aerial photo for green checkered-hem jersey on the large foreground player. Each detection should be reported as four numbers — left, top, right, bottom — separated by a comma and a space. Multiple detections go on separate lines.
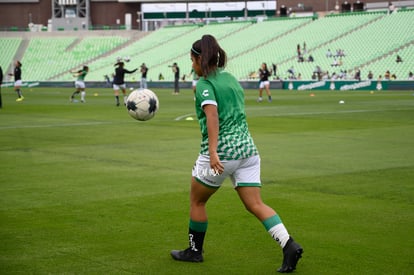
195, 70, 258, 160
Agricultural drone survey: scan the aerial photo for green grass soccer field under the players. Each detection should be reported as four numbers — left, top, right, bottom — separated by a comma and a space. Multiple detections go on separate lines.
0, 87, 414, 274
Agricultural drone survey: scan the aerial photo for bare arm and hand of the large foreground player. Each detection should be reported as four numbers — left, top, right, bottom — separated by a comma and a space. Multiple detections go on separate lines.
203, 104, 224, 174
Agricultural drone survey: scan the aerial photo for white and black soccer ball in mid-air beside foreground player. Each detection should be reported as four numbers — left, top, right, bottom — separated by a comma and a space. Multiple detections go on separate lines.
126, 89, 160, 121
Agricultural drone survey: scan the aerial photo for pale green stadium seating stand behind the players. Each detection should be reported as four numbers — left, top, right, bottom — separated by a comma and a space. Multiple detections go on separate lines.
0, 9, 414, 81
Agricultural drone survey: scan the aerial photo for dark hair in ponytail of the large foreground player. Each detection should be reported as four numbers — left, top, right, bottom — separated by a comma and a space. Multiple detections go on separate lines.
191, 34, 227, 77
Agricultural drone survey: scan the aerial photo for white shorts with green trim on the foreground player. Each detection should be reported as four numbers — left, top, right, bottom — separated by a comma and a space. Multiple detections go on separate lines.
192, 155, 262, 188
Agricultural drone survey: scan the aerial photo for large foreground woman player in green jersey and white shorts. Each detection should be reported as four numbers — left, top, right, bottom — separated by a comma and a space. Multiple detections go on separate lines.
171, 35, 303, 273
